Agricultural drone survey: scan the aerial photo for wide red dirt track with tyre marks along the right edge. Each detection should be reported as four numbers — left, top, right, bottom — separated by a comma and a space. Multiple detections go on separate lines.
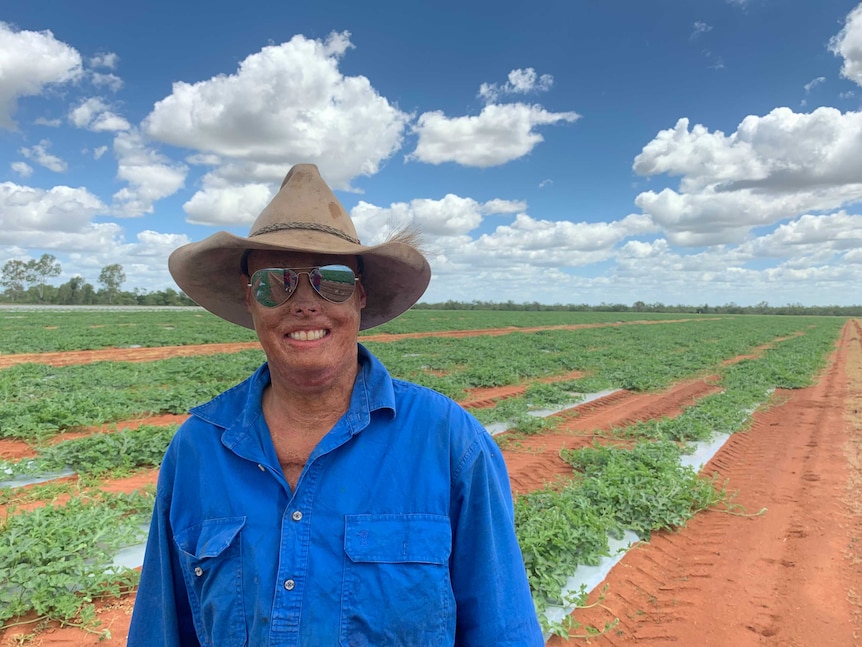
548, 323, 862, 647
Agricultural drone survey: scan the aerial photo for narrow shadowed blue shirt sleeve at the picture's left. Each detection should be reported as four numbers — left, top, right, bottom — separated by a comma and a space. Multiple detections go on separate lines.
126, 464, 200, 647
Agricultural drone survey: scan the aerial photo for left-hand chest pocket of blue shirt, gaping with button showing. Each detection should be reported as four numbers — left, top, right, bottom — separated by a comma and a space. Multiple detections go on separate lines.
174, 517, 248, 647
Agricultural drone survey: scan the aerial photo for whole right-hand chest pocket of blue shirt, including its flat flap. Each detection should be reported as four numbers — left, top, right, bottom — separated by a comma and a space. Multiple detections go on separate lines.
341, 514, 455, 647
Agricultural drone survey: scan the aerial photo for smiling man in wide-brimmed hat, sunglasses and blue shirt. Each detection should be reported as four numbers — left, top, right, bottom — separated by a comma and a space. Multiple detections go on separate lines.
128, 164, 544, 647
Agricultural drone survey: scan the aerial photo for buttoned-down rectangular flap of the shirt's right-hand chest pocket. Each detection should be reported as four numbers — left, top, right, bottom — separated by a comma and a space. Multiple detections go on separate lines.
344, 514, 452, 564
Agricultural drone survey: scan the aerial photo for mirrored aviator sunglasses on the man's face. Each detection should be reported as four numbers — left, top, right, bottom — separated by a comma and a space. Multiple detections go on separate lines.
248, 265, 359, 308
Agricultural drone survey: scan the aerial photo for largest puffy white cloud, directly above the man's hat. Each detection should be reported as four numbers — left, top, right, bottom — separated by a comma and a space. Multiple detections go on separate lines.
143, 32, 410, 188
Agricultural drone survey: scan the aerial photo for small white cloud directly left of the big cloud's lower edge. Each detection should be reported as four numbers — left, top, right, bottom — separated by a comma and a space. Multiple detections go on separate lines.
112, 131, 188, 217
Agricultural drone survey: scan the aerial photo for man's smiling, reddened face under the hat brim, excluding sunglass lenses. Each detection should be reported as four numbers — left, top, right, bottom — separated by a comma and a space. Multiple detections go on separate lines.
243, 250, 365, 390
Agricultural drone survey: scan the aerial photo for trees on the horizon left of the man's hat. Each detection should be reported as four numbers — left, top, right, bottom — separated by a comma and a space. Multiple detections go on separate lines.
0, 254, 194, 306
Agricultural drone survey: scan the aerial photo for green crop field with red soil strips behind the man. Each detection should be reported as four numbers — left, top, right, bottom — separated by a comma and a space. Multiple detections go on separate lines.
0, 310, 862, 647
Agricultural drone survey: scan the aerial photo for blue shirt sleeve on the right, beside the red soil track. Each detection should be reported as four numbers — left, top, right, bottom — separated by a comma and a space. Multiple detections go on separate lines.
451, 423, 544, 647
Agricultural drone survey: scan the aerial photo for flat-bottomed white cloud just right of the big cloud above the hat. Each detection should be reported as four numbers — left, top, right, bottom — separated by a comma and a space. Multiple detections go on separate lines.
407, 103, 580, 167
